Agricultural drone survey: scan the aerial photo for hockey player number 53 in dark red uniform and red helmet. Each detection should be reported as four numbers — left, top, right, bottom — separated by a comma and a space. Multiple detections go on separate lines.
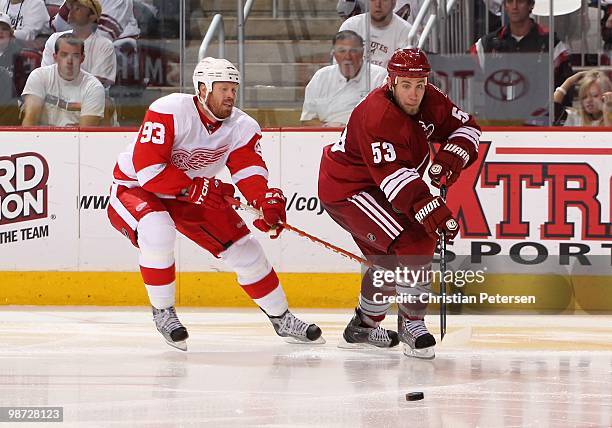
319, 48, 480, 358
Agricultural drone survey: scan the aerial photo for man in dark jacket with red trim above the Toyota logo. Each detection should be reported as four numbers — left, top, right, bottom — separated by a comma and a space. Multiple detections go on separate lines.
471, 0, 573, 105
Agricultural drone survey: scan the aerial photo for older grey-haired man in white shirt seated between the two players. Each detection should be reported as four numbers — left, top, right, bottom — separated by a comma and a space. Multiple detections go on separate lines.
300, 30, 387, 126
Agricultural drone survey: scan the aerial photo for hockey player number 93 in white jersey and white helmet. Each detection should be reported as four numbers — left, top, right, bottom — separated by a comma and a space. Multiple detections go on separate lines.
108, 58, 323, 350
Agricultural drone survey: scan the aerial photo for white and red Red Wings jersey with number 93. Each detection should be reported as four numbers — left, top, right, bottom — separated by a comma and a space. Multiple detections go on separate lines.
113, 93, 268, 201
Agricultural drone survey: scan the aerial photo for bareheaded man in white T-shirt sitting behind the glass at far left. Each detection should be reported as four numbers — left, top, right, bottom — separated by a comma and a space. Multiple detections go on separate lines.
22, 34, 104, 126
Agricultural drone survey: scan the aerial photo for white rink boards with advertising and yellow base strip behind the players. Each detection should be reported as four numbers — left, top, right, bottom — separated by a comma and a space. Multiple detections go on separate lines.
0, 128, 612, 307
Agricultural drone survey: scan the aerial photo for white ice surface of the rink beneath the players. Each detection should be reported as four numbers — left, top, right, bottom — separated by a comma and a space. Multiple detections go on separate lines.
0, 307, 612, 428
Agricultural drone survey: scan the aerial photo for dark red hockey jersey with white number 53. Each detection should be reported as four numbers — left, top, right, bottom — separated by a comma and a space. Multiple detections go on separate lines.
319, 84, 480, 214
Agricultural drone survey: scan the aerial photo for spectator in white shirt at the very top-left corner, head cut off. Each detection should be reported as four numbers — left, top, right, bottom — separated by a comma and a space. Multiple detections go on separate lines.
0, 0, 51, 43
